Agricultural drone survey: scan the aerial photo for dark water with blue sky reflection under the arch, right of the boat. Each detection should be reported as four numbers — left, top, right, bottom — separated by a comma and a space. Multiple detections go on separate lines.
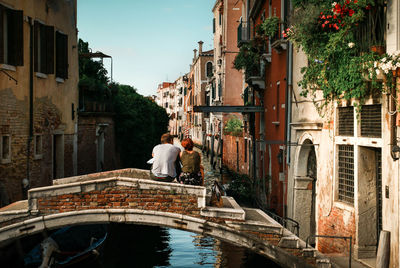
100, 224, 280, 268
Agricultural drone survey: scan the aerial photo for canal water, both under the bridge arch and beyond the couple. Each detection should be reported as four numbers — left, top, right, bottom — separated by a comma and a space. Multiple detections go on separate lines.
0, 143, 280, 268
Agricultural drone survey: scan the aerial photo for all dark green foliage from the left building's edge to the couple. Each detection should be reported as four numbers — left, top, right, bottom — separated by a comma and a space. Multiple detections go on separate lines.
78, 40, 169, 169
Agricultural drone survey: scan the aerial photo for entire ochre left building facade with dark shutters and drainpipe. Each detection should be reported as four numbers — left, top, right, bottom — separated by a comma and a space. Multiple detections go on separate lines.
0, 0, 78, 205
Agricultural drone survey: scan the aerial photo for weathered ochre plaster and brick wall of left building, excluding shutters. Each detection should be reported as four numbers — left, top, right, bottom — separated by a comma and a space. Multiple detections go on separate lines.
0, 0, 78, 201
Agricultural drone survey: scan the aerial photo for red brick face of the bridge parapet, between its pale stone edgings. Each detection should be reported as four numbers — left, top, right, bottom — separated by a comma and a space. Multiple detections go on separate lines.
37, 186, 200, 216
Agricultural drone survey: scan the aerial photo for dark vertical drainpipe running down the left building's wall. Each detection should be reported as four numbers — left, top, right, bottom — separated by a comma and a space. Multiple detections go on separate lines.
22, 17, 33, 196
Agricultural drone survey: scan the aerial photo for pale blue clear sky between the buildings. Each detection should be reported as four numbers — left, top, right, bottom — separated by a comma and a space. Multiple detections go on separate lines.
78, 0, 215, 96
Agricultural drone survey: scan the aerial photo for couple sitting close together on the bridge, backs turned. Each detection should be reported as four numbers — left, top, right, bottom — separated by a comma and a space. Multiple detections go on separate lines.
150, 133, 203, 185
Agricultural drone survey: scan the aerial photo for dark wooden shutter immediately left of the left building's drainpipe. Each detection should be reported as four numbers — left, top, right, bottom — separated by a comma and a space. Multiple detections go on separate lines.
8, 9, 24, 66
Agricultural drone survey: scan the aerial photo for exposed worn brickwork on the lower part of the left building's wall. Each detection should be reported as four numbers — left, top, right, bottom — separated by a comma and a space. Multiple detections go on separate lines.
0, 89, 73, 205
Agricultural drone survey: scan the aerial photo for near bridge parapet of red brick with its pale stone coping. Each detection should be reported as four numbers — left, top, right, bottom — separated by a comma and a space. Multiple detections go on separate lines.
28, 177, 206, 217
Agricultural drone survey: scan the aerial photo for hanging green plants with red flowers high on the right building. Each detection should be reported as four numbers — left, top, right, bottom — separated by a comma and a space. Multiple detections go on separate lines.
287, 0, 382, 115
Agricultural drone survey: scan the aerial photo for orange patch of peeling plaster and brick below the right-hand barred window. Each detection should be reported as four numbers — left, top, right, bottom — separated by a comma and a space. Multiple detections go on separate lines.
317, 207, 356, 254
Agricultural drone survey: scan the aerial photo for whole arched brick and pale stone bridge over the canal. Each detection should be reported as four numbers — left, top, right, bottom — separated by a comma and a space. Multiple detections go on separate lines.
0, 169, 336, 267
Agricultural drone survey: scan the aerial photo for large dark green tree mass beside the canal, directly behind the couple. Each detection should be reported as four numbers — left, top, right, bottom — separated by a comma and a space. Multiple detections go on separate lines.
113, 84, 169, 169
